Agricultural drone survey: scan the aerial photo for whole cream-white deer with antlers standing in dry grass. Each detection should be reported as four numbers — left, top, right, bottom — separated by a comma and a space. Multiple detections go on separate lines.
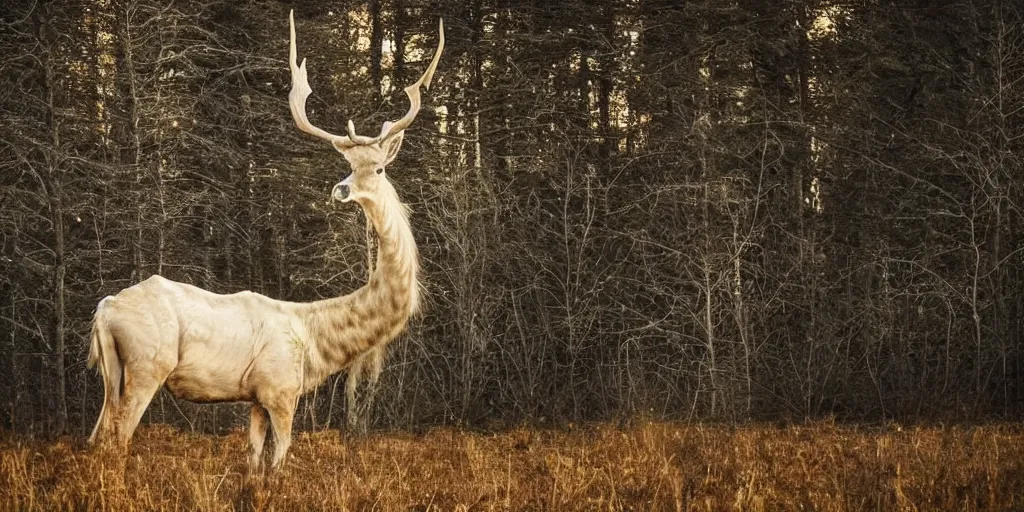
89, 9, 444, 469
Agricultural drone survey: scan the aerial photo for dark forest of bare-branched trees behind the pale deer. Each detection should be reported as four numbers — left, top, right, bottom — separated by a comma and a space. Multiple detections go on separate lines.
0, 0, 1024, 432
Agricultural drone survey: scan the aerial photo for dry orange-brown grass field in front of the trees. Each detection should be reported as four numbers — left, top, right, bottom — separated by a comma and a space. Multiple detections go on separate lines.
0, 423, 1024, 511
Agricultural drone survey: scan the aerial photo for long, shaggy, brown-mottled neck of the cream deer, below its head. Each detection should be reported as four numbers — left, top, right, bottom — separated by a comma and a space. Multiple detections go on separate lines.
305, 180, 420, 380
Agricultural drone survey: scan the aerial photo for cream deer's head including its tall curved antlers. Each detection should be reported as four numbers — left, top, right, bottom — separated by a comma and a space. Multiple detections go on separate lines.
288, 12, 444, 203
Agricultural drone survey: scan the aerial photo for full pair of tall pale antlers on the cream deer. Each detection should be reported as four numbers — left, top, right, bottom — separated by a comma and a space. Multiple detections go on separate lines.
288, 11, 444, 148
